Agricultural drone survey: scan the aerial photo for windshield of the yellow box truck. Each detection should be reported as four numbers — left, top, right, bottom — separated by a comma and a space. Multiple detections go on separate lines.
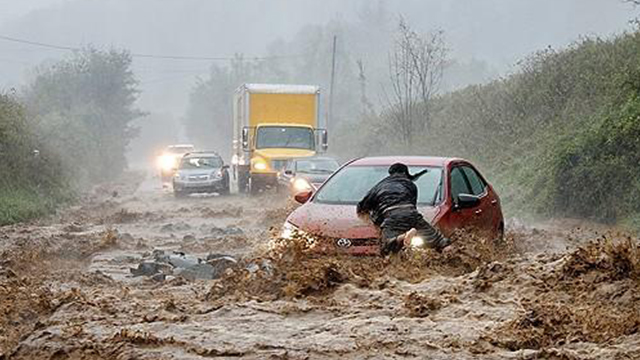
256, 126, 315, 150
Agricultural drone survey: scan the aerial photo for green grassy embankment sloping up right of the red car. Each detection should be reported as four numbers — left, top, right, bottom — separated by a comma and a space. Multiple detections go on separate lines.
417, 32, 640, 229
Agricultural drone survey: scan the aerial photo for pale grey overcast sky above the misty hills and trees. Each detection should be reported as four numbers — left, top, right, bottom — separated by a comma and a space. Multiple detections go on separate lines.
0, 0, 636, 114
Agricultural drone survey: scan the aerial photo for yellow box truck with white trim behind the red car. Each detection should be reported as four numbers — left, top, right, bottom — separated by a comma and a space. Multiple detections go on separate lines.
231, 84, 328, 193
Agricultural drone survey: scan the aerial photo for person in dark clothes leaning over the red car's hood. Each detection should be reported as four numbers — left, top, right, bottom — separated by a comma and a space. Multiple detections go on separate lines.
356, 163, 451, 256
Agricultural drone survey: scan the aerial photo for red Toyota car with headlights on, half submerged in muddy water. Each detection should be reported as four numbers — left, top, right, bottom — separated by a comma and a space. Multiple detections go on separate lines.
282, 156, 504, 255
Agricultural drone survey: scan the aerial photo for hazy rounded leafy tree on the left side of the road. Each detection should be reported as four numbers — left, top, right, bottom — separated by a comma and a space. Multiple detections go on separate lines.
25, 48, 143, 184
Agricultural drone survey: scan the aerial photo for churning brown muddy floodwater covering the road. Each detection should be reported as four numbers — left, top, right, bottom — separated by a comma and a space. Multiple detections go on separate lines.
0, 174, 640, 359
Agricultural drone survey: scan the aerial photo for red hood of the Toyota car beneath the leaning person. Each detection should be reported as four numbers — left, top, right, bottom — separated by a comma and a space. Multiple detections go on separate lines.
287, 202, 438, 239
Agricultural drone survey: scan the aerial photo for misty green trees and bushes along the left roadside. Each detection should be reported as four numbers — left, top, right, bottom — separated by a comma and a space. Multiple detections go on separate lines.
0, 48, 142, 225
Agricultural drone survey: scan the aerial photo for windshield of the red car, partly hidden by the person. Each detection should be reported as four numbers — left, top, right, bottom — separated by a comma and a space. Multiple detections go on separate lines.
315, 166, 442, 205
